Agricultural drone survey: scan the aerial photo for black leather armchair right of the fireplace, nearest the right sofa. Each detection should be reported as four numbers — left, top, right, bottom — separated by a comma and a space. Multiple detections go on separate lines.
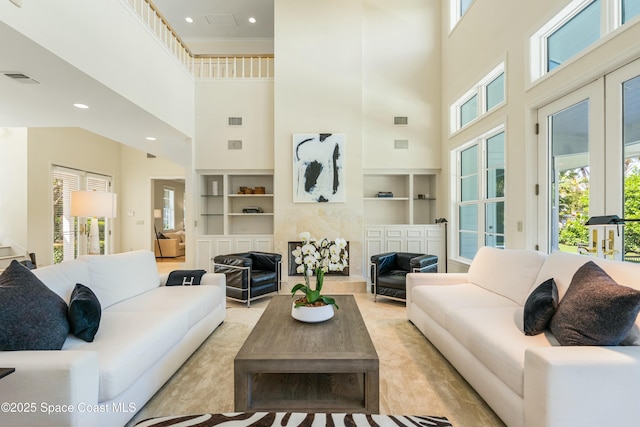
371, 252, 438, 300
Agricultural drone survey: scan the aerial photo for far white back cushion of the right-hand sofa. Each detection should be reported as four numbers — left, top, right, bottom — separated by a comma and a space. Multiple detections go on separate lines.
469, 246, 547, 306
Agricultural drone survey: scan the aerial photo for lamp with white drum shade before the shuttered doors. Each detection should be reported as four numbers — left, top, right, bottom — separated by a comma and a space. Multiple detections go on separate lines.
71, 191, 118, 255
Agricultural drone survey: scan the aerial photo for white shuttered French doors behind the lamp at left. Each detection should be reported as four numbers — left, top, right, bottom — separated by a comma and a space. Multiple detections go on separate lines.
52, 166, 111, 263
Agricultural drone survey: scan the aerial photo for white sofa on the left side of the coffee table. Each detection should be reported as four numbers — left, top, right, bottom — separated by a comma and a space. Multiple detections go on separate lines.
0, 251, 226, 427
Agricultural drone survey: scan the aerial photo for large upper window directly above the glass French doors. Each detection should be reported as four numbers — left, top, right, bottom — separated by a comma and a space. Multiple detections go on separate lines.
530, 0, 640, 81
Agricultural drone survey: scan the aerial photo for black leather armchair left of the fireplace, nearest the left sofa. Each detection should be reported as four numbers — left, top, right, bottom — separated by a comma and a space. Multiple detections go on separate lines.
213, 251, 282, 307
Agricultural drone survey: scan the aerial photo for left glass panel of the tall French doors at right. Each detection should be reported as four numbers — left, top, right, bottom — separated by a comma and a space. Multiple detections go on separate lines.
538, 80, 605, 253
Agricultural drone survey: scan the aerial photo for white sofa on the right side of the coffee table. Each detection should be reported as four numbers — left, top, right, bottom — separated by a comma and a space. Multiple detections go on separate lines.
407, 247, 640, 427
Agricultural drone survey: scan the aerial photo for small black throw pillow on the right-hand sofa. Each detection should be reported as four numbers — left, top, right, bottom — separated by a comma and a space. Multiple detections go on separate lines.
524, 279, 558, 335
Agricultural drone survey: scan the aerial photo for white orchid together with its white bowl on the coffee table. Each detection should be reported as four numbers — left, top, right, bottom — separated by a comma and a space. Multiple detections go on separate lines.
291, 231, 349, 322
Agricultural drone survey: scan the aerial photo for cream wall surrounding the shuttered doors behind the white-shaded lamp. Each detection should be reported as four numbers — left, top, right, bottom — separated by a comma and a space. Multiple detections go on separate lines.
26, 128, 122, 265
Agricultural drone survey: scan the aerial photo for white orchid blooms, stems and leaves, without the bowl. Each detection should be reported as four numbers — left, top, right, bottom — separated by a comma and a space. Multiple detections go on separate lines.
291, 231, 349, 308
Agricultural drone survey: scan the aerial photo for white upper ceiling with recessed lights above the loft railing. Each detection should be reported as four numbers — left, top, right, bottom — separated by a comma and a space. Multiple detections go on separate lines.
153, 0, 273, 46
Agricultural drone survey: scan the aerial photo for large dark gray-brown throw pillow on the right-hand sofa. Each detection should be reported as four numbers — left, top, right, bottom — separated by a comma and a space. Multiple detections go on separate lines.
550, 261, 640, 345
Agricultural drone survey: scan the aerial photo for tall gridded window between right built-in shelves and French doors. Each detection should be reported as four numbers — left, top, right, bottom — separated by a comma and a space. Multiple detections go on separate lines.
453, 127, 505, 260
